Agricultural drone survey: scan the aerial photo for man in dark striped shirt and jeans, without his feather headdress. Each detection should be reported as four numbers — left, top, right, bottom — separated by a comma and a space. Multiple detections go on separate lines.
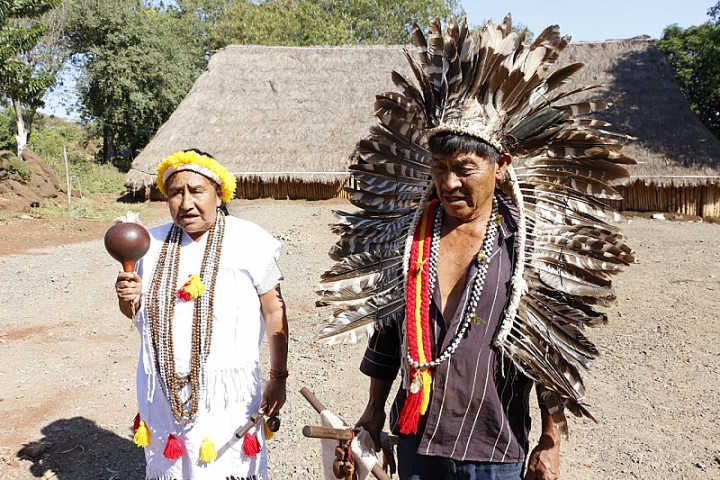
357, 133, 560, 479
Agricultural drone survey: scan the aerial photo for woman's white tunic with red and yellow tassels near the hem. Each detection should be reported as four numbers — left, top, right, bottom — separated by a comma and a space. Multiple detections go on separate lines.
136, 216, 283, 480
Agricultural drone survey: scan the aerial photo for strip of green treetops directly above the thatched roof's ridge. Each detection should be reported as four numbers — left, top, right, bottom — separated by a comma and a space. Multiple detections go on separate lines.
179, 0, 459, 49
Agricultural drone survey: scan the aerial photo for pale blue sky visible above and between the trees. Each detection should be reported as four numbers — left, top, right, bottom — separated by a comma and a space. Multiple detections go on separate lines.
40, 0, 717, 120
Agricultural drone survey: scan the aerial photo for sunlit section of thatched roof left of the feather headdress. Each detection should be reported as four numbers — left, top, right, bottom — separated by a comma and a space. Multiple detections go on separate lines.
126, 45, 410, 190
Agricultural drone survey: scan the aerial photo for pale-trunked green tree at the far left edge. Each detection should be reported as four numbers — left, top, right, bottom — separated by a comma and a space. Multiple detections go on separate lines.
0, 0, 60, 158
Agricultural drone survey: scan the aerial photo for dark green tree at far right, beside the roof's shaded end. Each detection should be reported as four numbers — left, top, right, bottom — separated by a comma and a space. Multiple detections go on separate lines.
657, 19, 720, 138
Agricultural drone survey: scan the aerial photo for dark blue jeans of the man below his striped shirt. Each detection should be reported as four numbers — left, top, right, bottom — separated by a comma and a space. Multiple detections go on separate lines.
397, 435, 523, 480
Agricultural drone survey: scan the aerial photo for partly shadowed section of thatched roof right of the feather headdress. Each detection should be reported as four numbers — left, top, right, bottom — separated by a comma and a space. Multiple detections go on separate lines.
561, 37, 720, 185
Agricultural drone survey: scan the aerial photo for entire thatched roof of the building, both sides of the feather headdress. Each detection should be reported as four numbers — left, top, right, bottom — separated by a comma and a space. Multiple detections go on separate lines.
126, 38, 720, 190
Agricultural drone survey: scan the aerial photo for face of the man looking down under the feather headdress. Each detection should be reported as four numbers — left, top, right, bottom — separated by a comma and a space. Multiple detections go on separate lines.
430, 152, 512, 222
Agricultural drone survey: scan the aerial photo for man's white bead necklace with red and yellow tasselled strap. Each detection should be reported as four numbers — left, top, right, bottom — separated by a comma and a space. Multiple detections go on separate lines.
398, 196, 501, 434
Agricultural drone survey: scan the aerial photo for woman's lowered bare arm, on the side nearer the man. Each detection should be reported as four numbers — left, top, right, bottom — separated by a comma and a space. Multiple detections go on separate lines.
260, 285, 289, 416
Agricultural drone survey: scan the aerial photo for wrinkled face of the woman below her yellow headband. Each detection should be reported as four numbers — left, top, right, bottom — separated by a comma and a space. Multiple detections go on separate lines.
165, 170, 221, 240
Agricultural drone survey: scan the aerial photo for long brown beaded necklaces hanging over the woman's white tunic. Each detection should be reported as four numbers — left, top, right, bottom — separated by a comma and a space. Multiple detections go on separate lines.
148, 211, 225, 425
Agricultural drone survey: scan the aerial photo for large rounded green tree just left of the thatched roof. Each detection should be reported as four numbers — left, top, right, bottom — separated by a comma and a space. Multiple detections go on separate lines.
67, 0, 206, 161
